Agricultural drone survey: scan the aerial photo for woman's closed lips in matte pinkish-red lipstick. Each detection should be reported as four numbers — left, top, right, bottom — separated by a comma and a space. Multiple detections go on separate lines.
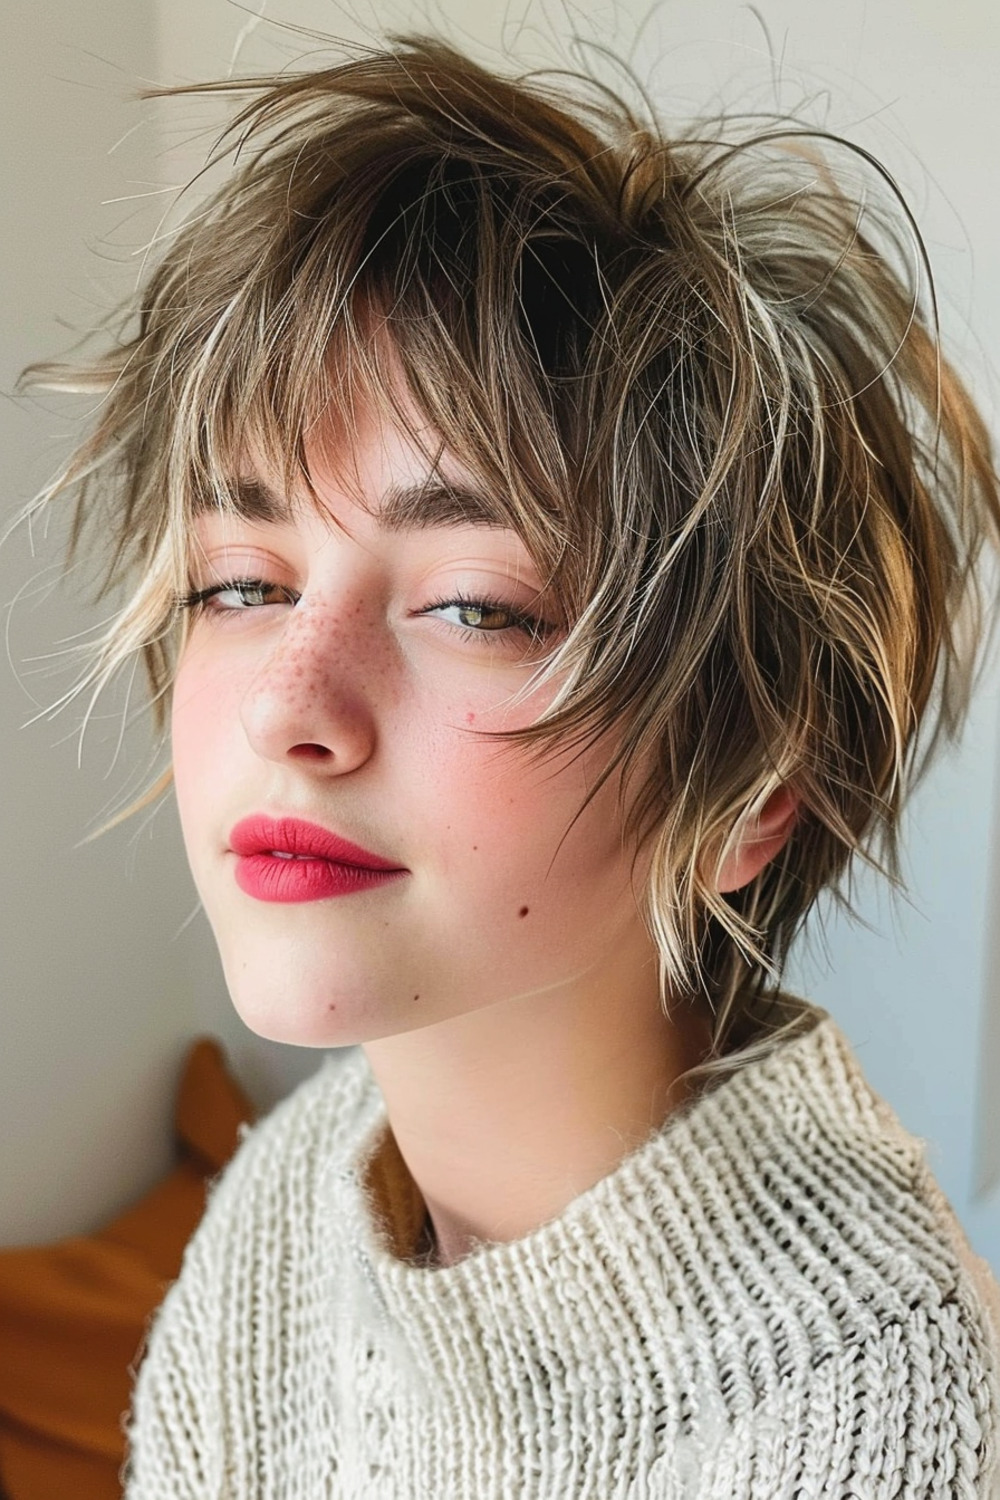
229, 815, 406, 902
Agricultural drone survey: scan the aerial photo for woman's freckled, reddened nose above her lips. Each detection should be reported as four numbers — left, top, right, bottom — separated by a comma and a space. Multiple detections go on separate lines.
240, 600, 375, 776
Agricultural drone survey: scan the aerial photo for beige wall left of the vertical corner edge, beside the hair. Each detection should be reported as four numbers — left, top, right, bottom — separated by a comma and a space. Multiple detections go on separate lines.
0, 0, 187, 1242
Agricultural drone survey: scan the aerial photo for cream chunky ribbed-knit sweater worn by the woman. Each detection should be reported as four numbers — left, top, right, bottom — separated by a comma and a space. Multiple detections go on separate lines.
126, 1007, 1000, 1500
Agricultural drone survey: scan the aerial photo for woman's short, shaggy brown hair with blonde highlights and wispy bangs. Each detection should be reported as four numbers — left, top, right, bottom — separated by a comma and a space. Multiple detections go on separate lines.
21, 36, 1000, 1092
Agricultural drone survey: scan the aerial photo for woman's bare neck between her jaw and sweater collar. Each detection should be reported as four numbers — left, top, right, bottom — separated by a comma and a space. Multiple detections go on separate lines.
364, 942, 711, 1266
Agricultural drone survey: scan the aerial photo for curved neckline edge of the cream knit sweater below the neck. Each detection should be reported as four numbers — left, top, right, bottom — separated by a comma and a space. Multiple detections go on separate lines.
316, 1001, 833, 1301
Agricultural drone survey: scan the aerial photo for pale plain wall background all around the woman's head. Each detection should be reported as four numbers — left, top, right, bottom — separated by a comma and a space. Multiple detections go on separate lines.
0, 0, 1000, 1269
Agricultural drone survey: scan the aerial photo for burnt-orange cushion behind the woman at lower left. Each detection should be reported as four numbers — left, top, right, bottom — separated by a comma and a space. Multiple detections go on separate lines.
0, 1037, 253, 1500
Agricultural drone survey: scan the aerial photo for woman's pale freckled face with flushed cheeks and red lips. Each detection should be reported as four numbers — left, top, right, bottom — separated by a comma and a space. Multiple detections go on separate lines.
172, 405, 652, 1047
